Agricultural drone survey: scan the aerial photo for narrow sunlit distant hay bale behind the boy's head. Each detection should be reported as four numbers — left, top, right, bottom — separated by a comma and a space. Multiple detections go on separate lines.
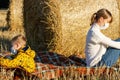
8, 0, 25, 36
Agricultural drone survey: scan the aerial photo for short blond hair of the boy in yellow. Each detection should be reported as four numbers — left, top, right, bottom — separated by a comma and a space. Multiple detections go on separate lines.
11, 35, 27, 46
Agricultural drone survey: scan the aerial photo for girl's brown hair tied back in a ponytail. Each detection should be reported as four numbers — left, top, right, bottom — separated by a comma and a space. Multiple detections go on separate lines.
90, 9, 113, 25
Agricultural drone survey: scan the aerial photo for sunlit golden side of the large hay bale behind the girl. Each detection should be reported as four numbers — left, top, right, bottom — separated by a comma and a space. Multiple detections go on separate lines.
59, 0, 120, 55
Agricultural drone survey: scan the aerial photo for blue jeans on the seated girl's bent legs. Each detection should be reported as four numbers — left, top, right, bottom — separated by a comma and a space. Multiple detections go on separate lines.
95, 38, 120, 67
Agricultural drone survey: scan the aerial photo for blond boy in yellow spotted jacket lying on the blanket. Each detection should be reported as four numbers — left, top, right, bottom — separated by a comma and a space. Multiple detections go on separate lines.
0, 35, 35, 73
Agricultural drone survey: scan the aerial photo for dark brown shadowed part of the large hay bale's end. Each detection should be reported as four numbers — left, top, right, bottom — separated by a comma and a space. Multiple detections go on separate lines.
24, 0, 54, 51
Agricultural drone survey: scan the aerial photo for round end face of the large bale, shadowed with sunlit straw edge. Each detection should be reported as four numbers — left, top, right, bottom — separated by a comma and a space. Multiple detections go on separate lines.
24, 0, 61, 51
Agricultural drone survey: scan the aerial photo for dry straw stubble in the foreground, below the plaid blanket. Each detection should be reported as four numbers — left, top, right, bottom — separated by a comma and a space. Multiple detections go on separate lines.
0, 67, 120, 80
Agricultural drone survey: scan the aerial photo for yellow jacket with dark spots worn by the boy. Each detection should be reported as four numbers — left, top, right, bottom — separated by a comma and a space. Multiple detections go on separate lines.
0, 47, 36, 73
